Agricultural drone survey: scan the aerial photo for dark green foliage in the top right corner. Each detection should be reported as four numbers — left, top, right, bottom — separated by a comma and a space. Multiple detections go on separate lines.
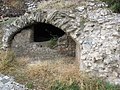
101, 0, 120, 13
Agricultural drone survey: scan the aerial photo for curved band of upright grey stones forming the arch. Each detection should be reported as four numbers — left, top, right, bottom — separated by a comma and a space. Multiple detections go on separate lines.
2, 10, 77, 49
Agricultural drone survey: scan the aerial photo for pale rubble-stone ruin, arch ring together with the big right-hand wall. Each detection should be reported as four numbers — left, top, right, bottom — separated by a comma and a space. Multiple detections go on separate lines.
2, 0, 120, 84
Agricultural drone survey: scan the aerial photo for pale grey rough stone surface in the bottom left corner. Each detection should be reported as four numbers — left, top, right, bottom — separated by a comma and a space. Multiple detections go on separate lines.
0, 74, 27, 90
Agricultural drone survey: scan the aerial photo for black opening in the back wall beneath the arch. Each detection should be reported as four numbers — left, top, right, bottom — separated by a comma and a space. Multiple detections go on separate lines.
33, 23, 65, 42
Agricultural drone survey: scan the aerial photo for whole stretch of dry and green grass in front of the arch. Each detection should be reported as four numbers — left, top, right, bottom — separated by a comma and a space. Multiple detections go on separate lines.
0, 52, 120, 90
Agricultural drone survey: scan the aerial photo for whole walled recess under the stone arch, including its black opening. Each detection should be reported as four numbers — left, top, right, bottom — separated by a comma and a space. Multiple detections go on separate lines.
12, 23, 76, 60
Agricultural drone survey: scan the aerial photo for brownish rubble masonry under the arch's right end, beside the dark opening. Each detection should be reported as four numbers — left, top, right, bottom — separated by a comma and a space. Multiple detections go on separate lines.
54, 35, 76, 57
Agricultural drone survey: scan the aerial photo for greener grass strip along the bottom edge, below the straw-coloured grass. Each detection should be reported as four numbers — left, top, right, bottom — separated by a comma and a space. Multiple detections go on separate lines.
51, 79, 120, 90
